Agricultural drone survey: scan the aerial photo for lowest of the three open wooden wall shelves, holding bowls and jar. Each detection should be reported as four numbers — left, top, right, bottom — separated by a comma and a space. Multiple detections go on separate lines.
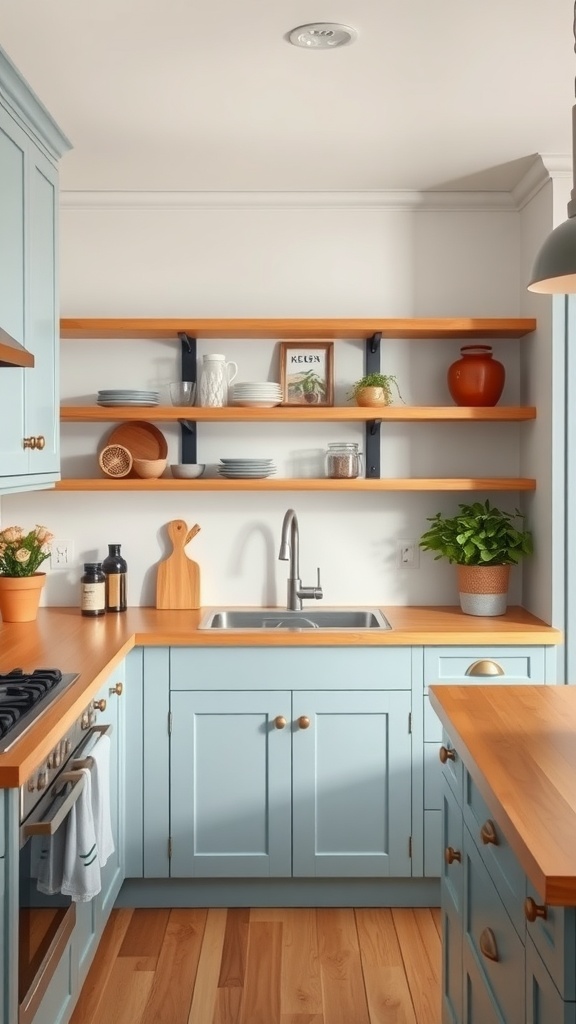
55, 476, 536, 492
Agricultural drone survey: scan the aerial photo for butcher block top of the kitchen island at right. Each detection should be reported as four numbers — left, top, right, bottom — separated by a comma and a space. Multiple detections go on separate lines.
430, 685, 576, 906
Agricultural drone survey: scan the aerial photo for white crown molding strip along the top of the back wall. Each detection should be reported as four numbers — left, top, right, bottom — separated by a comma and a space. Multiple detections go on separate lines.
60, 189, 517, 213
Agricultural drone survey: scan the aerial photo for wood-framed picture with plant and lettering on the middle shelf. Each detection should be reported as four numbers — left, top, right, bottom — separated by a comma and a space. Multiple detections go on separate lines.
280, 341, 334, 406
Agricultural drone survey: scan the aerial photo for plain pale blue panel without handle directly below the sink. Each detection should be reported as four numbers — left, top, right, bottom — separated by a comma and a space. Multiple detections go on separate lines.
170, 647, 412, 690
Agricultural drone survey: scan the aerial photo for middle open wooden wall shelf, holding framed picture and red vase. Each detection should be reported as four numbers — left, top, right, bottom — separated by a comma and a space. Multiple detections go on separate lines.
60, 406, 536, 423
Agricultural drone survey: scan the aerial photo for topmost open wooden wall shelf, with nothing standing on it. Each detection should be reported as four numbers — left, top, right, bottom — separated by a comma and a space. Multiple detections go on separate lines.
60, 316, 536, 341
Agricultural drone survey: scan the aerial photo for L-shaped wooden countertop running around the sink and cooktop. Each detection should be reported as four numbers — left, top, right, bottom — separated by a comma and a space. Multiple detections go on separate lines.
0, 606, 557, 786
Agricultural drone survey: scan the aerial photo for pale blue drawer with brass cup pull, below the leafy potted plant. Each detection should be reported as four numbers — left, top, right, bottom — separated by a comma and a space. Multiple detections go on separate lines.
424, 647, 546, 688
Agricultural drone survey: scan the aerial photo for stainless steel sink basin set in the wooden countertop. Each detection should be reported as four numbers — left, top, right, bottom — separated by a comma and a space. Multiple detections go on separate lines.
198, 608, 392, 630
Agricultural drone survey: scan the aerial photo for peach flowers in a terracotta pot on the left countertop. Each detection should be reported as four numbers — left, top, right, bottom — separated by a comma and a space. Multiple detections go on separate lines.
0, 526, 53, 623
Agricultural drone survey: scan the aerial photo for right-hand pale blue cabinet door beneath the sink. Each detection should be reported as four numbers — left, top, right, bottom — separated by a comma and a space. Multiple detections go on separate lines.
292, 690, 412, 878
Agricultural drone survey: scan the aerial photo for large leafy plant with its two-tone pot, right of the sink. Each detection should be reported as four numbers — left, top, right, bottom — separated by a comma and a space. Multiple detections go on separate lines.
419, 500, 533, 615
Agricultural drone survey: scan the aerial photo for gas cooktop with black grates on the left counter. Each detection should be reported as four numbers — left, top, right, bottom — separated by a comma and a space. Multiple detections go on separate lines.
0, 669, 78, 754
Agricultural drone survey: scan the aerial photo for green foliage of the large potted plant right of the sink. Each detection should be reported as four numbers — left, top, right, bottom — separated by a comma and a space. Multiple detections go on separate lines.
419, 501, 533, 565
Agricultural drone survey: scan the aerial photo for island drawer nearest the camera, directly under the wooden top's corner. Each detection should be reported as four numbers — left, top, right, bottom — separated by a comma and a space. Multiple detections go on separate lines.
526, 883, 576, 999
